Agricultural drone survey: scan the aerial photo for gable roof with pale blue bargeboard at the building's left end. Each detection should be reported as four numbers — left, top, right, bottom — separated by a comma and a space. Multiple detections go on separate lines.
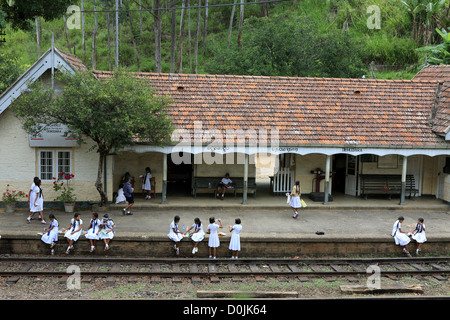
0, 48, 88, 114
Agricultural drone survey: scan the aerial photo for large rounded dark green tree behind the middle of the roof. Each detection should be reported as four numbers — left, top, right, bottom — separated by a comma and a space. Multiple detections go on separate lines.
206, 16, 364, 77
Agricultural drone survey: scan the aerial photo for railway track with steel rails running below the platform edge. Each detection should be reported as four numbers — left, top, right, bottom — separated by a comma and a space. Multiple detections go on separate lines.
0, 257, 450, 283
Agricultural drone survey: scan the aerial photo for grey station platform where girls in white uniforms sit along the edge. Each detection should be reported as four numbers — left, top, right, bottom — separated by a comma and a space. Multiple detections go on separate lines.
0, 195, 450, 257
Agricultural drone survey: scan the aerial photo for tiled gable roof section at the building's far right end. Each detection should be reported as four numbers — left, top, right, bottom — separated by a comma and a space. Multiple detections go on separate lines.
413, 65, 450, 135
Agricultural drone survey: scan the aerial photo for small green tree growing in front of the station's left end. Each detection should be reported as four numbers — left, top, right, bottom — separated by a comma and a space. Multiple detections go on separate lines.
13, 71, 172, 205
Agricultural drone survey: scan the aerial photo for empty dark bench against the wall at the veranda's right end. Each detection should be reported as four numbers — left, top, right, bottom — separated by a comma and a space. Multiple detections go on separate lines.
360, 174, 419, 200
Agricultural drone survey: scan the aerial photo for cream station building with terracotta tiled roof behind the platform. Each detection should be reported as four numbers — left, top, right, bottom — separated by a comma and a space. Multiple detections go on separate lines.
0, 48, 450, 205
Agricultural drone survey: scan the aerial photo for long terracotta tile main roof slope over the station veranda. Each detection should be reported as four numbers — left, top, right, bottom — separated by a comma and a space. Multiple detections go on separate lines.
94, 71, 447, 148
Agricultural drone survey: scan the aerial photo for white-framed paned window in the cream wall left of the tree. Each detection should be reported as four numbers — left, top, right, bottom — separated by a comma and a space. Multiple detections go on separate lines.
38, 150, 72, 181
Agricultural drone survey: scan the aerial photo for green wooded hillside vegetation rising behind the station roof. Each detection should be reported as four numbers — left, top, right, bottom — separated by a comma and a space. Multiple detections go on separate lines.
0, 0, 450, 79
